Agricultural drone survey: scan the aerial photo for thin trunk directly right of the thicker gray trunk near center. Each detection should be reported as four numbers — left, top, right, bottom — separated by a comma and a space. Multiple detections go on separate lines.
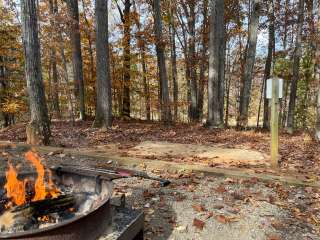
170, 1, 178, 121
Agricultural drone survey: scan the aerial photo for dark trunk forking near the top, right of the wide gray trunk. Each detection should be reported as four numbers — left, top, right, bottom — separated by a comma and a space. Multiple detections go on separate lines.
117, 0, 132, 118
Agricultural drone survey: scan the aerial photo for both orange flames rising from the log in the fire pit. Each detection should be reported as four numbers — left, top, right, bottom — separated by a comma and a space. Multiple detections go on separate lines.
4, 151, 60, 206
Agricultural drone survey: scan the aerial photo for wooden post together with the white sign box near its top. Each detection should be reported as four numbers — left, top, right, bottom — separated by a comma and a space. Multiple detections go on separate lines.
266, 77, 283, 168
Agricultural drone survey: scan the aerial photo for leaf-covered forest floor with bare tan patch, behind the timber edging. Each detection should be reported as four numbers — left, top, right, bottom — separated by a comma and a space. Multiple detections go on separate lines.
0, 121, 320, 179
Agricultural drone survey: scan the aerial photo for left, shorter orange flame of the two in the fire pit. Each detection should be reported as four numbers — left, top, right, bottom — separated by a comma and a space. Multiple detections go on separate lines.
4, 163, 26, 205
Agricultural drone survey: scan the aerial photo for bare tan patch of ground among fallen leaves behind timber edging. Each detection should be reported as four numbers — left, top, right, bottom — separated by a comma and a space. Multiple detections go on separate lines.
127, 141, 269, 165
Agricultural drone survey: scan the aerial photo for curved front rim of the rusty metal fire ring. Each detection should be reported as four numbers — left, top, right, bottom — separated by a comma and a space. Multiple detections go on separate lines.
0, 172, 110, 239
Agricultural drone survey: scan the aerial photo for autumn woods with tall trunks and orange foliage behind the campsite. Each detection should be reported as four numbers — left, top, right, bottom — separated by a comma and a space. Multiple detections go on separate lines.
0, 0, 320, 142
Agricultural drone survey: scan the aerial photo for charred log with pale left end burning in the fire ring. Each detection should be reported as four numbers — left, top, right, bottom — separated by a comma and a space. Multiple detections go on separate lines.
0, 194, 76, 231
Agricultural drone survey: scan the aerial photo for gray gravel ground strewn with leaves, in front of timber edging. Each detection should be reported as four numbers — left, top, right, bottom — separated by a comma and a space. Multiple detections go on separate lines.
0, 145, 320, 240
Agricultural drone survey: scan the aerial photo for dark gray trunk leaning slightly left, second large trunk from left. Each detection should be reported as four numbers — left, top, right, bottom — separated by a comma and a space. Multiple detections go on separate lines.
67, 0, 86, 120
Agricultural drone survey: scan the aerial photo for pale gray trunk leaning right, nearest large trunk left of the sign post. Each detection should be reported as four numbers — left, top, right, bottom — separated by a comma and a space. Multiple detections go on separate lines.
237, 0, 261, 127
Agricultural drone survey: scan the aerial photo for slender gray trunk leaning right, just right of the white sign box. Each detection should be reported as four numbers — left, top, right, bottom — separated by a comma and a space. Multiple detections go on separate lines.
287, 0, 304, 133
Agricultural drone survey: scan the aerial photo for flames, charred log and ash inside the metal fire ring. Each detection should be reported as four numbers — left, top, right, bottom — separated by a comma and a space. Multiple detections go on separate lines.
0, 151, 109, 234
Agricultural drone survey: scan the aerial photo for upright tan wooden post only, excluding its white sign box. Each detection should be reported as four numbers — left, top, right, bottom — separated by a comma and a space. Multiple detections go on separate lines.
271, 77, 279, 168
